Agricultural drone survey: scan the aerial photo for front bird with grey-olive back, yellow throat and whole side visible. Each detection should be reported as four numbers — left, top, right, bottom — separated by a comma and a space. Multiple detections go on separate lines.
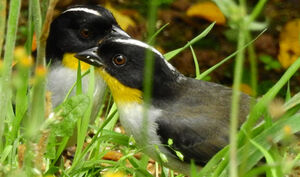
76, 36, 252, 175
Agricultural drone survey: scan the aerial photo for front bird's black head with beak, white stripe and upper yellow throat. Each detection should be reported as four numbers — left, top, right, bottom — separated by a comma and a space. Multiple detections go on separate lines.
75, 37, 183, 102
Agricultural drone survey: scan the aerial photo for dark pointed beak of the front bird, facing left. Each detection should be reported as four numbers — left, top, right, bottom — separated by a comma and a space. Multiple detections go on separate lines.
75, 47, 103, 67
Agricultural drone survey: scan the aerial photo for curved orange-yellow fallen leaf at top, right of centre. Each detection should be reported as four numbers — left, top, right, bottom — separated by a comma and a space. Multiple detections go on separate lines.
186, 1, 226, 25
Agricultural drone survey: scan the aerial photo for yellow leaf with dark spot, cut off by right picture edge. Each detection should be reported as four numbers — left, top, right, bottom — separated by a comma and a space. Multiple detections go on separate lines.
278, 18, 300, 68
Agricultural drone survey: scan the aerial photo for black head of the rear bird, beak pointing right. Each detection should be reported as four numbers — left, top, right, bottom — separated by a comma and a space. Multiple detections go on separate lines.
46, 5, 129, 62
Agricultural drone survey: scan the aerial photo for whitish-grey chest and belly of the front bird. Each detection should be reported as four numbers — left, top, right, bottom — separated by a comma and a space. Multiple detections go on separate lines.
118, 104, 189, 171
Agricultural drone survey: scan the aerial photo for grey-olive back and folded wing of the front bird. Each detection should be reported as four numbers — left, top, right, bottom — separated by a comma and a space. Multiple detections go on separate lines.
156, 81, 250, 165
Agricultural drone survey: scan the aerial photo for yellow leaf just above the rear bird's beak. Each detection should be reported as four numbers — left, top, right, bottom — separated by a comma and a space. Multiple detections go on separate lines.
105, 3, 135, 31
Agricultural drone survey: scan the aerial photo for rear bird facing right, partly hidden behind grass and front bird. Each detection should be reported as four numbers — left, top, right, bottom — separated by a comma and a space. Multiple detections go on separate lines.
46, 5, 129, 117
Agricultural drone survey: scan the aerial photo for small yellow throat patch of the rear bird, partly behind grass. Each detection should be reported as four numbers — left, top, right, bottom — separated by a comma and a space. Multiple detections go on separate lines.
62, 53, 90, 71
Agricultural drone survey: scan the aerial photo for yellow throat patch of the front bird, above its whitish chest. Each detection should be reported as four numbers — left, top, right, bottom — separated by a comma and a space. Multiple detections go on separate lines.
96, 68, 142, 104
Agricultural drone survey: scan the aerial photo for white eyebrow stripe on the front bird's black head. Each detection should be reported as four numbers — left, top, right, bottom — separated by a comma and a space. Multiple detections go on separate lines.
113, 39, 177, 72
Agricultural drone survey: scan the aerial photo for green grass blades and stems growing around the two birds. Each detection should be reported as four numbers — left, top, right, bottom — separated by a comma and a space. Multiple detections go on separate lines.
0, 0, 300, 177
